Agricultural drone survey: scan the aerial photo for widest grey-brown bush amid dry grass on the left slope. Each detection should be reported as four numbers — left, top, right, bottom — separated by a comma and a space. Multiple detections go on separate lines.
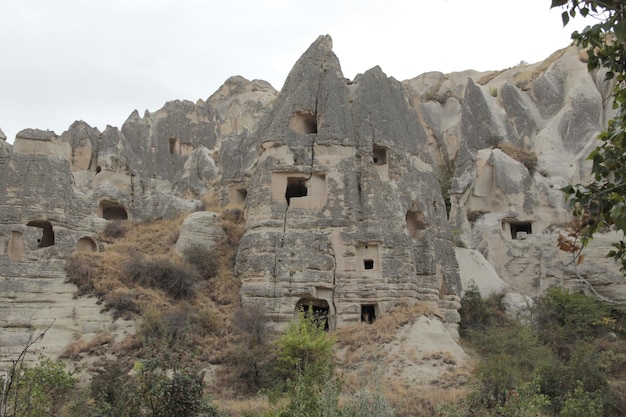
123, 257, 199, 299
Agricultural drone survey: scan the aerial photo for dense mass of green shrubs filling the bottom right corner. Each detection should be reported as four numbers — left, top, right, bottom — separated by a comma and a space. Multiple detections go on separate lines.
439, 287, 626, 417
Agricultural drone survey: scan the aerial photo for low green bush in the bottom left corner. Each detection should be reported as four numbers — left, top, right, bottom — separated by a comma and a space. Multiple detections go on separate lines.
0, 356, 77, 417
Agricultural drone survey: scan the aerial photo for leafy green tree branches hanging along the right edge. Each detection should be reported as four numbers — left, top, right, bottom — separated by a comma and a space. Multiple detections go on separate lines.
551, 0, 626, 275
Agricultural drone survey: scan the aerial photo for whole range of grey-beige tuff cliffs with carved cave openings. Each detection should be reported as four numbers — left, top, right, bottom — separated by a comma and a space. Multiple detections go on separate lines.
0, 36, 626, 355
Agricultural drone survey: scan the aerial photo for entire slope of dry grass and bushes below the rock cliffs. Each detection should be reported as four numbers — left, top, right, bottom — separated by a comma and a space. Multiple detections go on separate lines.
2, 213, 626, 417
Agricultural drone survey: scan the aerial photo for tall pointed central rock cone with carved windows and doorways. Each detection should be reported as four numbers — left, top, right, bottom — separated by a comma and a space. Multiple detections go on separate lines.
237, 37, 460, 328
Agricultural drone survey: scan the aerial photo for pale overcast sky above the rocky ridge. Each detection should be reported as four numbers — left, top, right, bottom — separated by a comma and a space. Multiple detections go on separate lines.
0, 0, 584, 142
